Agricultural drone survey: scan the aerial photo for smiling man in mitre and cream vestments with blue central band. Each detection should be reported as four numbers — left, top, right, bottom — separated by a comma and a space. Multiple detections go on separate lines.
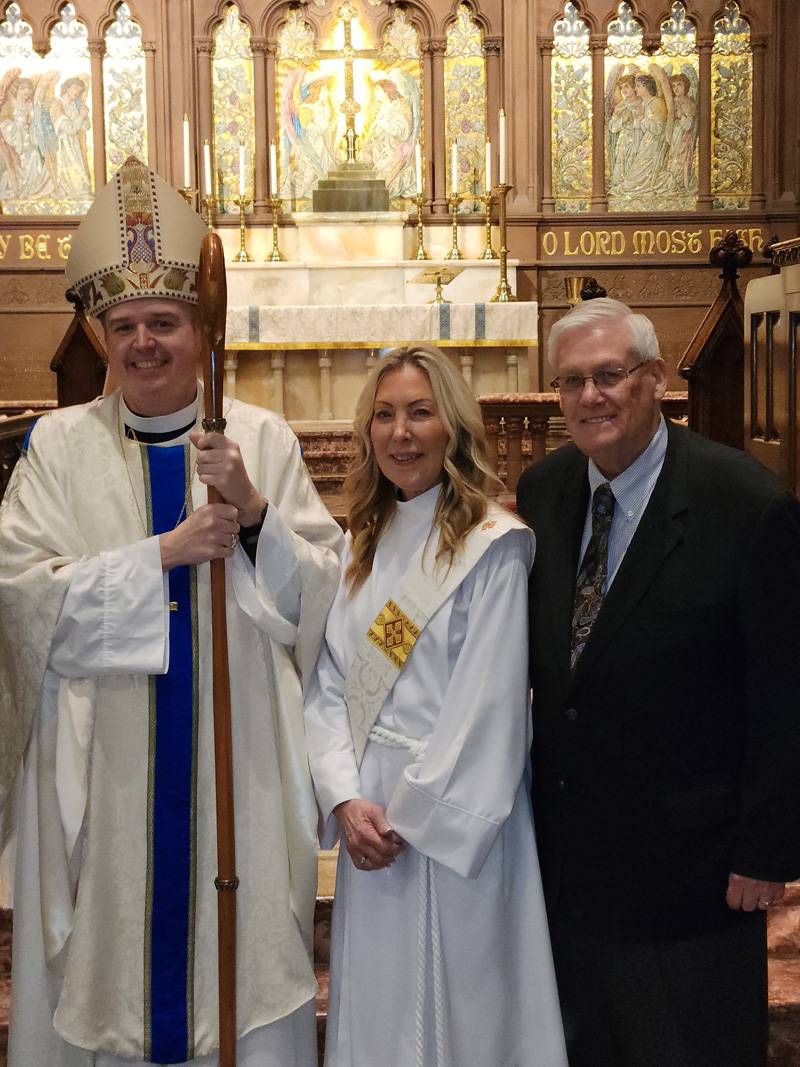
0, 160, 340, 1067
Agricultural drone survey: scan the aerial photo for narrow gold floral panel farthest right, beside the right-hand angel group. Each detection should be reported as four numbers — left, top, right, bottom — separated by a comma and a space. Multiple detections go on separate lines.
711, 2, 753, 210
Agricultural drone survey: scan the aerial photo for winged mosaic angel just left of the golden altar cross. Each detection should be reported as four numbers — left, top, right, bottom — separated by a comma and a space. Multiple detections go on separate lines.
281, 68, 337, 198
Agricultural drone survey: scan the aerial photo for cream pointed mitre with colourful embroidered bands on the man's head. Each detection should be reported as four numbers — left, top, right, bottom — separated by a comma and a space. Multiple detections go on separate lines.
66, 156, 206, 315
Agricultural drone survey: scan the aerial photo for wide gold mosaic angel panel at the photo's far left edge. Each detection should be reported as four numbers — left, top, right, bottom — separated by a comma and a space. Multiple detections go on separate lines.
0, 3, 94, 214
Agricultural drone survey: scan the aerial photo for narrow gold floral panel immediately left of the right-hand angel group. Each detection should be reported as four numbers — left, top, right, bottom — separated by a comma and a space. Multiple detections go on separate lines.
550, 3, 592, 211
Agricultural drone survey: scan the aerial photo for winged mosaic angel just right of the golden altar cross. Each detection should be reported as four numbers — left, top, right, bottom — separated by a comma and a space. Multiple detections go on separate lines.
365, 70, 420, 196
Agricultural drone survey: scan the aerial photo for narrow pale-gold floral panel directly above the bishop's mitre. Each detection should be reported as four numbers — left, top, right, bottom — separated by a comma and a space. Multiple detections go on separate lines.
102, 3, 147, 177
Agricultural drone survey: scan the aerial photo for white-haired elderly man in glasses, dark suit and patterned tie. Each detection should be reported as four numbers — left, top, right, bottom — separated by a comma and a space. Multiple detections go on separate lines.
518, 300, 800, 1067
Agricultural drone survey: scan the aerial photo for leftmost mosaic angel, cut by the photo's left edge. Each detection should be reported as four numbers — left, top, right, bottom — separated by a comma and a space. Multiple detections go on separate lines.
0, 68, 58, 201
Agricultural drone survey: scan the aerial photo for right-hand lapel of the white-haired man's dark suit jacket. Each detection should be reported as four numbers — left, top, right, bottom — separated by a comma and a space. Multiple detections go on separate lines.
572, 420, 688, 686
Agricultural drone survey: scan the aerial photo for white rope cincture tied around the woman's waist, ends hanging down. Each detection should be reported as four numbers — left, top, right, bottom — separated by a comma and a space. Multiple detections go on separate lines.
369, 726, 447, 1067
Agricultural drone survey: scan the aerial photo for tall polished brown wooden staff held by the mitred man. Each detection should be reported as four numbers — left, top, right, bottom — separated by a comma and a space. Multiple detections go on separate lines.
197, 233, 239, 1067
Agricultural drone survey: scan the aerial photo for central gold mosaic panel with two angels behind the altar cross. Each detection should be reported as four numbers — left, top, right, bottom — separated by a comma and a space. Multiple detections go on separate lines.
276, 3, 422, 211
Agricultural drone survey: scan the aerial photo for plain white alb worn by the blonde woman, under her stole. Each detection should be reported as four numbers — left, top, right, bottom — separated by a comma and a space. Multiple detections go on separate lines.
306, 487, 566, 1067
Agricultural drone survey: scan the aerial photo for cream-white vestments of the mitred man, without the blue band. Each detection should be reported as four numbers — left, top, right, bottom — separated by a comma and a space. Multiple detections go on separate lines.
0, 396, 340, 1067
